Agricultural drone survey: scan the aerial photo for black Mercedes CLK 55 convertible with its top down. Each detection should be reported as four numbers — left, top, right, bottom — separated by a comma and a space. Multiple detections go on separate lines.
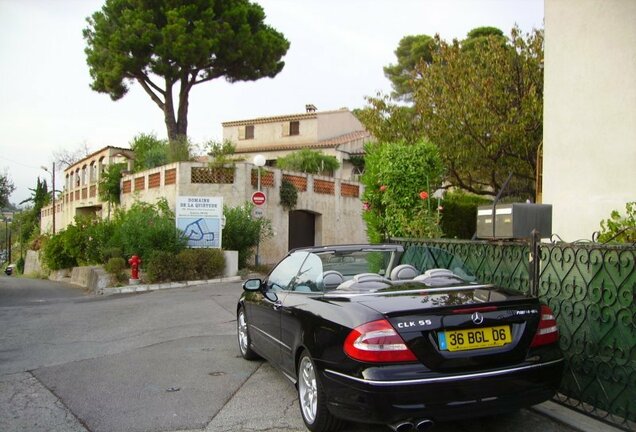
237, 245, 563, 432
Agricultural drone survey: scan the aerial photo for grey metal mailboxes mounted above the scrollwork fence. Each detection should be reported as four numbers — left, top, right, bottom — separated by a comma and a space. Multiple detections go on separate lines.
477, 203, 552, 239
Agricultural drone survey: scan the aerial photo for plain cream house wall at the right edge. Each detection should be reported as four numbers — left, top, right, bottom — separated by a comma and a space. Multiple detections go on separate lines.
543, 0, 636, 241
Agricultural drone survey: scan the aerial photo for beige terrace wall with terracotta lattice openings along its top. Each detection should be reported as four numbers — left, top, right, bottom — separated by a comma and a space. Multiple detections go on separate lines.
121, 162, 367, 264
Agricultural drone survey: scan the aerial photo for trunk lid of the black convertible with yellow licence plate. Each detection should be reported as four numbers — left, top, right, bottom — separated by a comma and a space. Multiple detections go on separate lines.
351, 284, 540, 371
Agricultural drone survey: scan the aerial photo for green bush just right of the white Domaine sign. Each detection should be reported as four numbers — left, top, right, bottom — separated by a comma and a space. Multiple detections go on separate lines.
222, 203, 272, 268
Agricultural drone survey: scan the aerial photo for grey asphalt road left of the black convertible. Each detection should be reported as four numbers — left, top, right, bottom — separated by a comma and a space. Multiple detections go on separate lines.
0, 276, 588, 432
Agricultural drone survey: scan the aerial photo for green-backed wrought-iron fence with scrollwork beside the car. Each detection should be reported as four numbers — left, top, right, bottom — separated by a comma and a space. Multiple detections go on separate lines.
392, 239, 636, 431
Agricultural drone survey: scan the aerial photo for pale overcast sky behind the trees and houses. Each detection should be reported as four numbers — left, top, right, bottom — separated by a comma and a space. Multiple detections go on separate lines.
0, 0, 543, 204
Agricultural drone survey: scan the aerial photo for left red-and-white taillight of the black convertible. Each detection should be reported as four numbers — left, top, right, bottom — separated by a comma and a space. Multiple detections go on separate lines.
344, 319, 417, 363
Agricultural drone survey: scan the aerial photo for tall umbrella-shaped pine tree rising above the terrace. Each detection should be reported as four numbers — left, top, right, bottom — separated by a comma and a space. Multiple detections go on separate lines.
84, 0, 289, 141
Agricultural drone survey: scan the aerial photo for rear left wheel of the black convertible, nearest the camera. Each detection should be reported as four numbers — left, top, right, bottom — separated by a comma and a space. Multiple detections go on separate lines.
297, 351, 344, 432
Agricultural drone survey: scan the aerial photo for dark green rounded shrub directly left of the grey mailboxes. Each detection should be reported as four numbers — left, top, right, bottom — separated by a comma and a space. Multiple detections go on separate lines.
441, 192, 492, 239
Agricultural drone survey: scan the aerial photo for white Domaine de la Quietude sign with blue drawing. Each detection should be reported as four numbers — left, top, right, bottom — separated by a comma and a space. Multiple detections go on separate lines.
175, 196, 223, 248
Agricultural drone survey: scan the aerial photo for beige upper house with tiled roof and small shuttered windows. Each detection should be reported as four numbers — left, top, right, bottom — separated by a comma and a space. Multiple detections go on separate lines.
222, 105, 372, 179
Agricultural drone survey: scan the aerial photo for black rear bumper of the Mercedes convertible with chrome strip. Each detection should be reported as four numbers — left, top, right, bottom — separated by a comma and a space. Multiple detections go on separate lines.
321, 358, 563, 424
